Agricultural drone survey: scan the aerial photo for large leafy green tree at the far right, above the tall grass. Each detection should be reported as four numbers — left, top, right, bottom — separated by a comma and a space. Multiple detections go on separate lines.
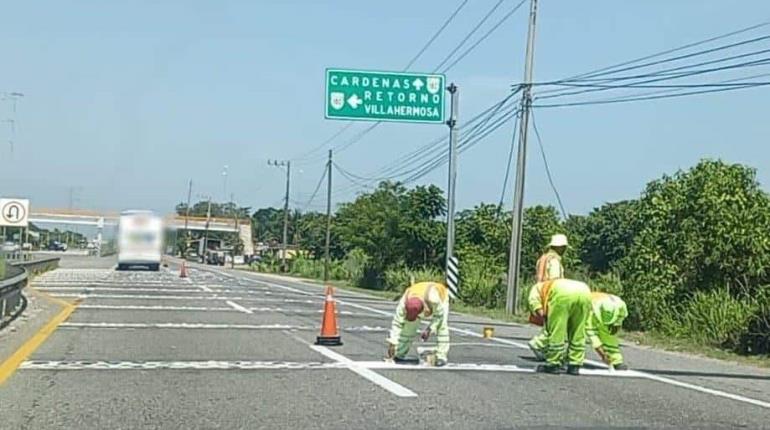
618, 160, 770, 328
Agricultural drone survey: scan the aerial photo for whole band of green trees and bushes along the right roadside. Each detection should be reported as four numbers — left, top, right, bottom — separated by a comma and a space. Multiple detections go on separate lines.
219, 160, 770, 356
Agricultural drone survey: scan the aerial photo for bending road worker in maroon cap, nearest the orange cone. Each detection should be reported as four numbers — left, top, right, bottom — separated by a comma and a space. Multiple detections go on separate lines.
388, 282, 449, 366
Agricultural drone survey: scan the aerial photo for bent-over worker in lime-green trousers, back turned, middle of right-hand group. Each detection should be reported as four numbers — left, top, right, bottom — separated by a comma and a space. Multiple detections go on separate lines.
528, 278, 591, 375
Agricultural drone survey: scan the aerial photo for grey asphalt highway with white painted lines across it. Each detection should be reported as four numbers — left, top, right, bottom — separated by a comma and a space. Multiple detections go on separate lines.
0, 254, 770, 429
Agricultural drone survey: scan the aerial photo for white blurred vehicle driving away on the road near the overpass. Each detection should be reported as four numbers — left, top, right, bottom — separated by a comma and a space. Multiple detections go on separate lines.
118, 210, 163, 271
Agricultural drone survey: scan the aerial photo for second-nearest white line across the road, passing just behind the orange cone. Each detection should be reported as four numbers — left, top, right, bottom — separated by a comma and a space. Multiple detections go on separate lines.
59, 322, 390, 333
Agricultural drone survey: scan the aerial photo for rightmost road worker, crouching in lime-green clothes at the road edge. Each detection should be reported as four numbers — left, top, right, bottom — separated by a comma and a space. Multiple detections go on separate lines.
586, 292, 628, 370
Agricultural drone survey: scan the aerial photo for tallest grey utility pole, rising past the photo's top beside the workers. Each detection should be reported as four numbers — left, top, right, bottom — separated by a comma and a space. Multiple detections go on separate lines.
505, 0, 537, 314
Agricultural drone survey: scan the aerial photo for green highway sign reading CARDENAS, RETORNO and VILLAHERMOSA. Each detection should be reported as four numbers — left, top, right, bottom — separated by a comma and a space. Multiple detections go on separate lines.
325, 69, 445, 123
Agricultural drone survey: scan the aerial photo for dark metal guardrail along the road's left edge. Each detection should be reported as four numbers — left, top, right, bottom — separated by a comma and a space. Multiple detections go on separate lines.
0, 257, 59, 329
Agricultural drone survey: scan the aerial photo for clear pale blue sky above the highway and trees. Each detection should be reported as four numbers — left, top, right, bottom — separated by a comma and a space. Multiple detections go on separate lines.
0, 0, 770, 213
